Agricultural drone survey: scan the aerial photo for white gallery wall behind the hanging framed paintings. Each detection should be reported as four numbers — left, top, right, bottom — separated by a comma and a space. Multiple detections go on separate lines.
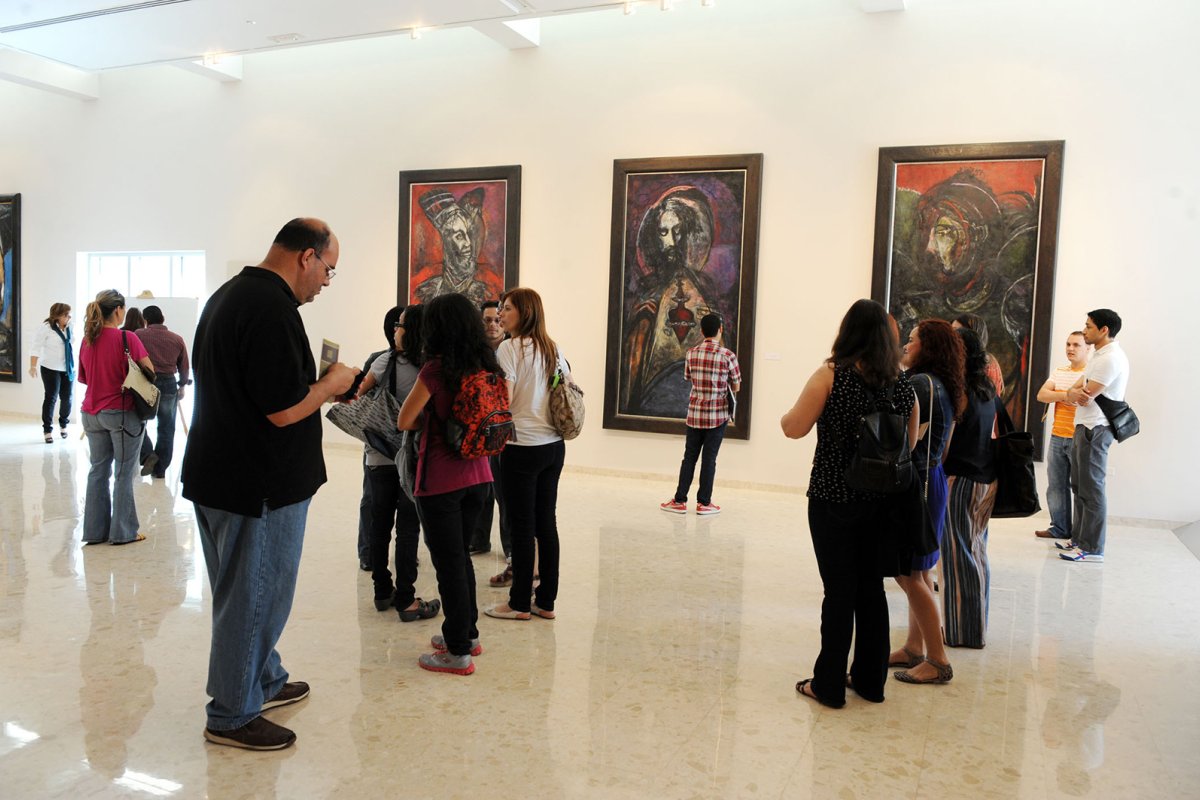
0, 0, 1200, 522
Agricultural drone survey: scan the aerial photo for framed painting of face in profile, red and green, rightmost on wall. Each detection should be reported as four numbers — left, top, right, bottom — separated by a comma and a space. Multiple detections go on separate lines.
871, 140, 1063, 459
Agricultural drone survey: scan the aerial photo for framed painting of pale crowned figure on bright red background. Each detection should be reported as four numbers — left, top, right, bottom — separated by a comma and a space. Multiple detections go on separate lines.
396, 166, 521, 305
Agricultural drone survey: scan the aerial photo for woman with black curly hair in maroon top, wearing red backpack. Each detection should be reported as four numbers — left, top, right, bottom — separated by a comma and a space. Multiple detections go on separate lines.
397, 294, 503, 675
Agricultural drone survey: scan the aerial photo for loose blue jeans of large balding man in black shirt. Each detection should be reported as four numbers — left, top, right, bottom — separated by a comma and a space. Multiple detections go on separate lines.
196, 498, 311, 730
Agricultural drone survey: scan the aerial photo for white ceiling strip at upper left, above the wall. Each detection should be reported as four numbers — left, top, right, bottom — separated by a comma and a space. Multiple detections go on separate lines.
0, 0, 633, 71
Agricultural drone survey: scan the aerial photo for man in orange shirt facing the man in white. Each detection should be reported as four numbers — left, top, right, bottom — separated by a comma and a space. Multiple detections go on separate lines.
1033, 331, 1092, 540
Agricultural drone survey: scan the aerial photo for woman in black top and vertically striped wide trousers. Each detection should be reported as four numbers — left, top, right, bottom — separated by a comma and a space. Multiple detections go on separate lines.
941, 329, 996, 648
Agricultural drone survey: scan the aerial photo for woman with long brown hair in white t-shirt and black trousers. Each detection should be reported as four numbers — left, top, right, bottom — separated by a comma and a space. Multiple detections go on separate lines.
484, 288, 570, 620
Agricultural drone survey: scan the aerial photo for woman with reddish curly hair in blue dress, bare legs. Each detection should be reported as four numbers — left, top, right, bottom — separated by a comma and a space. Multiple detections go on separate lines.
888, 319, 967, 684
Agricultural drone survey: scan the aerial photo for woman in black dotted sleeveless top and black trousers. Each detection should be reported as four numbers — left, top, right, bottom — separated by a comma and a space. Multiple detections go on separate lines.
780, 300, 918, 708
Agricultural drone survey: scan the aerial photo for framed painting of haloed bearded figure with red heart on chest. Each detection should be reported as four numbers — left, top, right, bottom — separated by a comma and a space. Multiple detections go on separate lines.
604, 154, 762, 439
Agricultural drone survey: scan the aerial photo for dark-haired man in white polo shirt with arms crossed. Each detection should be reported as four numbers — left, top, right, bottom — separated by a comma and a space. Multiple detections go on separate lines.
1056, 308, 1129, 564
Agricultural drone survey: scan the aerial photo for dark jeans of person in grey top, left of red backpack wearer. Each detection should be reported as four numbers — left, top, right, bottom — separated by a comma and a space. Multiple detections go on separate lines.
367, 464, 421, 609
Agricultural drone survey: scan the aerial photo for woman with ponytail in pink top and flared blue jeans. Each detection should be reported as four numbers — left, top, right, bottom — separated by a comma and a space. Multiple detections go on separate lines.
79, 289, 154, 545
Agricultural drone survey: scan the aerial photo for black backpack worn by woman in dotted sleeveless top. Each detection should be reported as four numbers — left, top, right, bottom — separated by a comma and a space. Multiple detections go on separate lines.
845, 383, 914, 494
